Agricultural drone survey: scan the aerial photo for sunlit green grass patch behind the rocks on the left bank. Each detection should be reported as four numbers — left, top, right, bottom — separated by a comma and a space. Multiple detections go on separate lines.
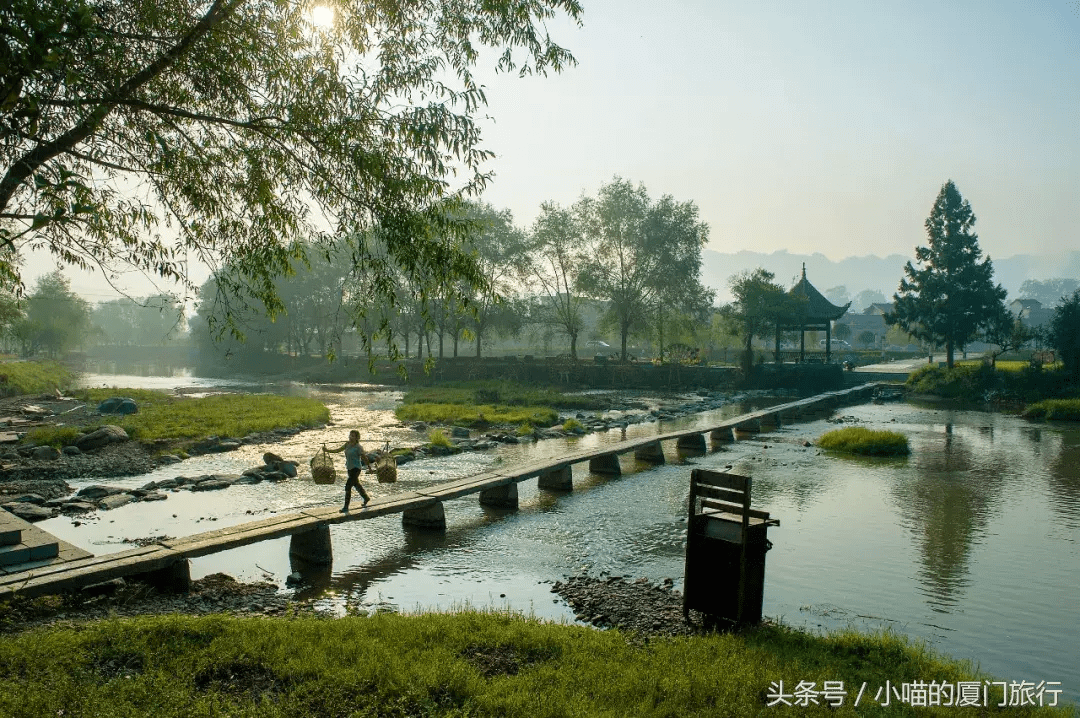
28, 389, 329, 444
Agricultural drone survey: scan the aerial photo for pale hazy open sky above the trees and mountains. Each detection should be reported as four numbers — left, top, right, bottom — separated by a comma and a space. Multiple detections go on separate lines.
19, 0, 1080, 301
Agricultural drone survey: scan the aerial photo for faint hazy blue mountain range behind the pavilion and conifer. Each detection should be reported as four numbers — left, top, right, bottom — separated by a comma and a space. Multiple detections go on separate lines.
701, 249, 1080, 302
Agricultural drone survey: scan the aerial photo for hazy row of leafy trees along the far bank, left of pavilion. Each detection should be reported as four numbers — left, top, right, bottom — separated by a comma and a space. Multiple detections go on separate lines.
194, 177, 713, 369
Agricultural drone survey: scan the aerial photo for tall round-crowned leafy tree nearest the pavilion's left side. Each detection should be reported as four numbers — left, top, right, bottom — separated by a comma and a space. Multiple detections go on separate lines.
578, 177, 711, 361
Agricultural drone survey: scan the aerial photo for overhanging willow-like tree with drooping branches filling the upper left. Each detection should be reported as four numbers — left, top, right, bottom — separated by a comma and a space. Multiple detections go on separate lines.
0, 0, 581, 347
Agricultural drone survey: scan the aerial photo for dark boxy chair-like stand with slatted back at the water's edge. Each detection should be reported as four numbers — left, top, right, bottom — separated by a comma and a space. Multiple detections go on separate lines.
683, 469, 780, 624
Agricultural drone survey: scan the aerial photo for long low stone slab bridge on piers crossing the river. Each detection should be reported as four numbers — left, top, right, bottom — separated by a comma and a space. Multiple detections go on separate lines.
0, 383, 894, 600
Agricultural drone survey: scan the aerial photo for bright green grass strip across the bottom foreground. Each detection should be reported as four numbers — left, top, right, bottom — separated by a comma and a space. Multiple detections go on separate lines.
0, 612, 1062, 718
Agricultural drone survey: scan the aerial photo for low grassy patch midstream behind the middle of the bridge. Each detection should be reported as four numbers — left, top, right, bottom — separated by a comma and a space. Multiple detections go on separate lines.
395, 381, 607, 426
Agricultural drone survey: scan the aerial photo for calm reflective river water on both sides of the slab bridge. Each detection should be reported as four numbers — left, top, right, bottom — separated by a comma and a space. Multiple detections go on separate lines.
41, 376, 1080, 703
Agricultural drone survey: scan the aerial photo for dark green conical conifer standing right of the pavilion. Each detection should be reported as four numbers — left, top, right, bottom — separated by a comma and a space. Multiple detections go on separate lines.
885, 180, 1005, 368
